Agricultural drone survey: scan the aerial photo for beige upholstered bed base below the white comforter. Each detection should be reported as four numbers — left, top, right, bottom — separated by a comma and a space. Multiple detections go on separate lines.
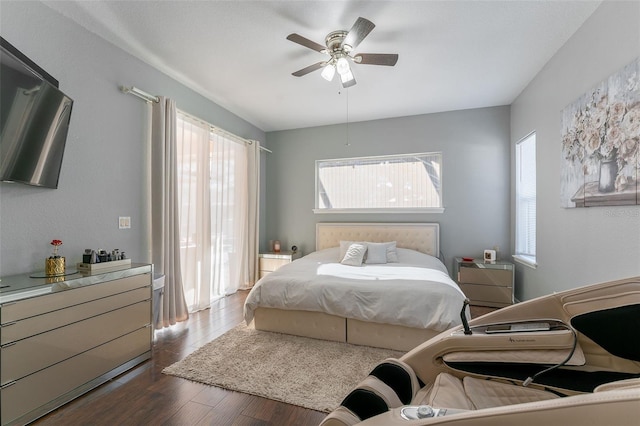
253, 308, 440, 352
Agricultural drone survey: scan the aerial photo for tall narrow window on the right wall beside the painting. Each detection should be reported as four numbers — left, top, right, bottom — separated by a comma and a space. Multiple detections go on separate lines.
514, 133, 536, 267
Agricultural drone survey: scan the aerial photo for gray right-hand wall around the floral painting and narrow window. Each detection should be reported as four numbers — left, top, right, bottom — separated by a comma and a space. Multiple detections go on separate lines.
511, 2, 640, 299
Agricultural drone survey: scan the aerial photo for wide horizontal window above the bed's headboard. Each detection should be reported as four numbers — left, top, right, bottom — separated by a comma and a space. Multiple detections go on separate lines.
314, 152, 444, 213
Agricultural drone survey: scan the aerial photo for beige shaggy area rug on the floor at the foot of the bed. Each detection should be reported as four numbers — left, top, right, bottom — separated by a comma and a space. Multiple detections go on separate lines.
162, 323, 403, 413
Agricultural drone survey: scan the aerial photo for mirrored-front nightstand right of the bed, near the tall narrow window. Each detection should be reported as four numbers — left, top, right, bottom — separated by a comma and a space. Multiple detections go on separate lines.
453, 257, 515, 308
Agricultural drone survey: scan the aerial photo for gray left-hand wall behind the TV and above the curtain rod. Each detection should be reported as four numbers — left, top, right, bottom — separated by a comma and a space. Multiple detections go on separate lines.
0, 1, 265, 276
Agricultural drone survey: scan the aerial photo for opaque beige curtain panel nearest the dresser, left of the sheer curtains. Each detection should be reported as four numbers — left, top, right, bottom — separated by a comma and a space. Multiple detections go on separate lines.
150, 97, 189, 328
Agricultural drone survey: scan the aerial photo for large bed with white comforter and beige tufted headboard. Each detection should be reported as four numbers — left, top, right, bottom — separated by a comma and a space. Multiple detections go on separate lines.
244, 223, 465, 351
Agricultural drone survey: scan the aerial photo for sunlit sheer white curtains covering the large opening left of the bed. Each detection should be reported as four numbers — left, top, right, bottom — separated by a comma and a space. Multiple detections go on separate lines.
177, 112, 259, 312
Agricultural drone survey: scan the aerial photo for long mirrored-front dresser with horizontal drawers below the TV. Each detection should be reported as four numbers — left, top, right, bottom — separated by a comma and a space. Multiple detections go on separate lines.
0, 264, 153, 425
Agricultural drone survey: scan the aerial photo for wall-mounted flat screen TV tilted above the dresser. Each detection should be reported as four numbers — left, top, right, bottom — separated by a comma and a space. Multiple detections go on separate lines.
0, 39, 73, 188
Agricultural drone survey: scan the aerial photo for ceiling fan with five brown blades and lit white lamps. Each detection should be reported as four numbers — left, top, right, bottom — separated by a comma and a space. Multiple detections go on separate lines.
287, 17, 398, 88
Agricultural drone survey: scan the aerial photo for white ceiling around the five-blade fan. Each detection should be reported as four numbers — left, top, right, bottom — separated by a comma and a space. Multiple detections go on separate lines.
45, 0, 601, 131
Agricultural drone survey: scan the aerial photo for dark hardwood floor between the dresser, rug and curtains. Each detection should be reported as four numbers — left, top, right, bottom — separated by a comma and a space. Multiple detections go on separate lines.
34, 291, 492, 426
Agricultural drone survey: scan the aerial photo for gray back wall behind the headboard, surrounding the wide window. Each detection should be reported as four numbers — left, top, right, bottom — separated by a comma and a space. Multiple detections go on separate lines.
262, 106, 510, 268
